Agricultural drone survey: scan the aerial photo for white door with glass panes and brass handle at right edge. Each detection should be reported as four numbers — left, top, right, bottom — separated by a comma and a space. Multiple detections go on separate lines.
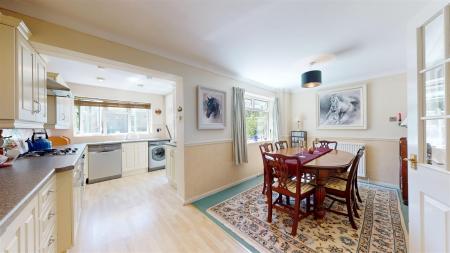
408, 3, 450, 253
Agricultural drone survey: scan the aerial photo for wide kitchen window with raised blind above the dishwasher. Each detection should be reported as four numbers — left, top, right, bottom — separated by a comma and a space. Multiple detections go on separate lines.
74, 98, 151, 136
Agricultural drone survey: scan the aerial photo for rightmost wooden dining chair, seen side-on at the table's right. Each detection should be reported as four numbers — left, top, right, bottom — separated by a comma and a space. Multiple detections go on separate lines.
325, 147, 364, 229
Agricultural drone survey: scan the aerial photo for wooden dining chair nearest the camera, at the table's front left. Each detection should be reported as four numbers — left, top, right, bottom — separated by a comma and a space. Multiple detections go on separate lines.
265, 153, 315, 236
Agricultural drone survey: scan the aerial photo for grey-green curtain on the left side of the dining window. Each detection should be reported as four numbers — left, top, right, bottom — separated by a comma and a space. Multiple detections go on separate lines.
232, 87, 248, 165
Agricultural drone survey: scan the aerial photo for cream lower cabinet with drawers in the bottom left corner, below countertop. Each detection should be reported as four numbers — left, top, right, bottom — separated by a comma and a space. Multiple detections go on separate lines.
0, 175, 57, 253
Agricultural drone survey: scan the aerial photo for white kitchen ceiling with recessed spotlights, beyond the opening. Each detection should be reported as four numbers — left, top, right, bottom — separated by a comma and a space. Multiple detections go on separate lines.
44, 55, 175, 95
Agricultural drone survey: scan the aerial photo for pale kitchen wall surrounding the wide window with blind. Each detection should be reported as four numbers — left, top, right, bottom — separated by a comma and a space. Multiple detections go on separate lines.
49, 83, 167, 143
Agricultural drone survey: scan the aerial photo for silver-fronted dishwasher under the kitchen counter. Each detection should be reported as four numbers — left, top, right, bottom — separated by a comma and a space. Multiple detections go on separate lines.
87, 143, 122, 184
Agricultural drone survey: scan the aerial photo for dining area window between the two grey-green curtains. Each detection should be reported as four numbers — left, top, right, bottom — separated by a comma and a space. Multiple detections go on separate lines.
245, 94, 272, 142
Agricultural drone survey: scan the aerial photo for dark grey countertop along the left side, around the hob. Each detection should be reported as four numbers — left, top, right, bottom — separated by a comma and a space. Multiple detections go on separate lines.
0, 144, 86, 234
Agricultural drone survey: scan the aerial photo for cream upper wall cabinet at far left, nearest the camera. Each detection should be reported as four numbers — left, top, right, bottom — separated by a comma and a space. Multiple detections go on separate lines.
0, 13, 47, 128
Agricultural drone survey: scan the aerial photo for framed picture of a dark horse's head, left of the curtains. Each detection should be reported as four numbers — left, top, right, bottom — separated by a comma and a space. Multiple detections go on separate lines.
197, 86, 226, 129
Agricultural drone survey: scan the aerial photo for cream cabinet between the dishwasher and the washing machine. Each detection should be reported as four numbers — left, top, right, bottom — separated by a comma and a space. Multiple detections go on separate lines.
122, 142, 148, 175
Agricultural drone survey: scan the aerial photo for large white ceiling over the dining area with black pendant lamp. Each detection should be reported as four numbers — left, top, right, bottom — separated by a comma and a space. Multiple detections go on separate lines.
0, 0, 432, 88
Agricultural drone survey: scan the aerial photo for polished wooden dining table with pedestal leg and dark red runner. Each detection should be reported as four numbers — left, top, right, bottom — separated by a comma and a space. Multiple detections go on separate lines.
270, 147, 355, 219
